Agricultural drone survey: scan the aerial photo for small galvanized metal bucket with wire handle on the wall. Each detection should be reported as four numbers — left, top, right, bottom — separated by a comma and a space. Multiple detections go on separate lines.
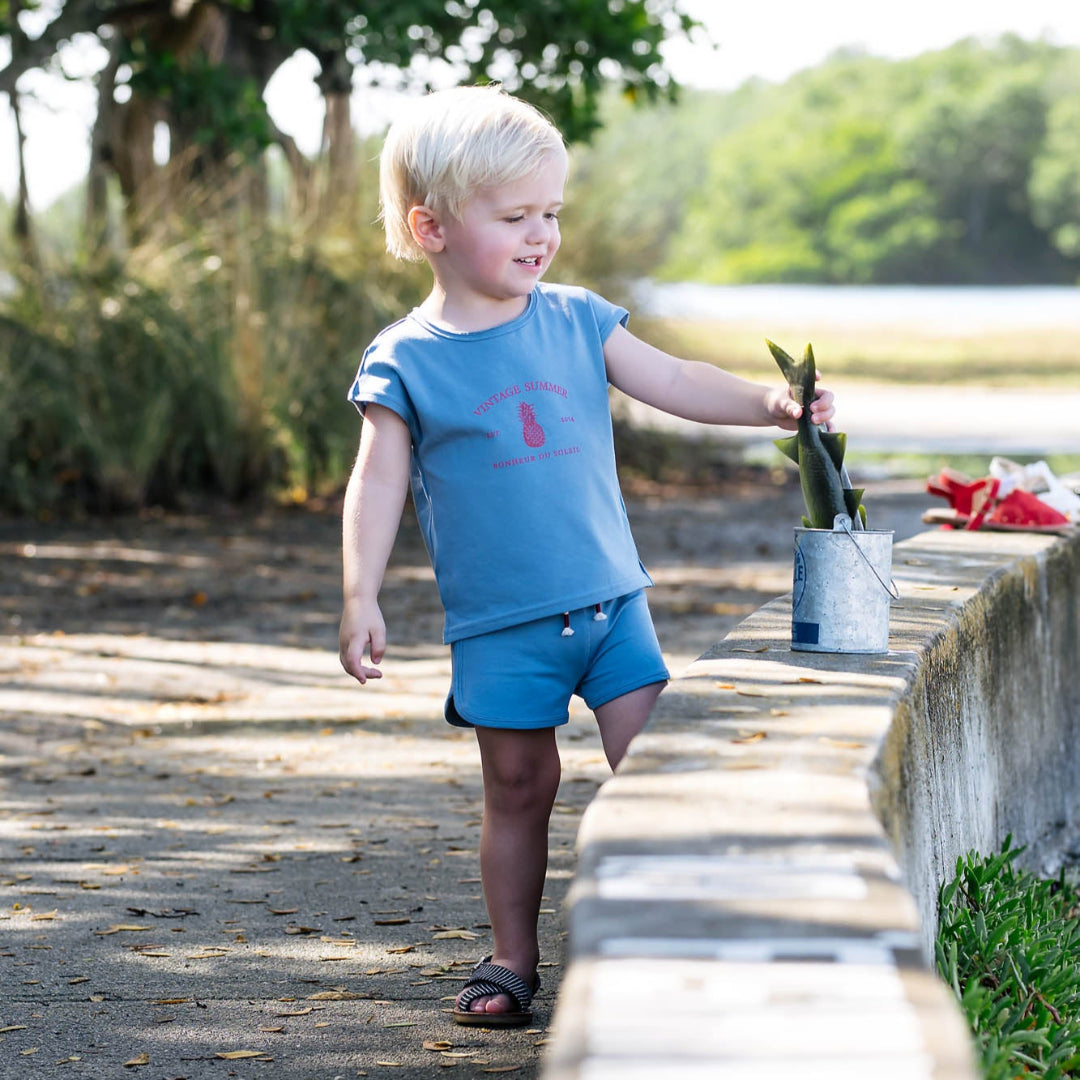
792, 514, 899, 652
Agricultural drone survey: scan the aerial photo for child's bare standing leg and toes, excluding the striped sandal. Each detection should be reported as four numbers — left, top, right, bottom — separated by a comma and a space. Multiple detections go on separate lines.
470, 728, 561, 1013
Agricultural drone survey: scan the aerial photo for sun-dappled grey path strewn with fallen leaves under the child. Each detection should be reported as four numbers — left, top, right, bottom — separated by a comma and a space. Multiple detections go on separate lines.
0, 485, 926, 1080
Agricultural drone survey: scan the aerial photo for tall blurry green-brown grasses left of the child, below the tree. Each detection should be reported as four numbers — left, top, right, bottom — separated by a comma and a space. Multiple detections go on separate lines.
0, 218, 416, 513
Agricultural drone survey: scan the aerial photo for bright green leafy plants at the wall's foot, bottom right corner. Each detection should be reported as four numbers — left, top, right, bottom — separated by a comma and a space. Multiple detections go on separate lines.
936, 838, 1080, 1080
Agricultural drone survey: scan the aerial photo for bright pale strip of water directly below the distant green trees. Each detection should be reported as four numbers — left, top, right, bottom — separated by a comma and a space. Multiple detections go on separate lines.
634, 281, 1080, 334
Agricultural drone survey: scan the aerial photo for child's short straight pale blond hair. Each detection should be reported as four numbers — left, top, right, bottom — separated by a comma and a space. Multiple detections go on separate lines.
379, 85, 566, 259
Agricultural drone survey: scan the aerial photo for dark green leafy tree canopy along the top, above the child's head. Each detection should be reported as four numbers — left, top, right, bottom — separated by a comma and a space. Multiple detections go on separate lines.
0, 0, 697, 150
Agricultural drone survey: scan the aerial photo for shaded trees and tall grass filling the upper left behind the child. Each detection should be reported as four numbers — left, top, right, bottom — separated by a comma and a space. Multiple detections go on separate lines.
0, 0, 691, 512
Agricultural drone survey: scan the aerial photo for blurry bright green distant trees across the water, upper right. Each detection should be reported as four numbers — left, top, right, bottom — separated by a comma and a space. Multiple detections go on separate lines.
597, 37, 1080, 284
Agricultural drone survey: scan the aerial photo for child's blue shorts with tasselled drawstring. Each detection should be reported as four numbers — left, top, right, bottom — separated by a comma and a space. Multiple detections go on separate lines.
445, 590, 669, 729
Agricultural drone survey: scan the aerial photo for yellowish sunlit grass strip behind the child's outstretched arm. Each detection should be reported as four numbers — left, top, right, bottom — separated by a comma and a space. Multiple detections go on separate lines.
634, 319, 1080, 390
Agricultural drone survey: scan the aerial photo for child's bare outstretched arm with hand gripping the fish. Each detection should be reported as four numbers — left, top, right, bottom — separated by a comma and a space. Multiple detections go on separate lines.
604, 326, 835, 430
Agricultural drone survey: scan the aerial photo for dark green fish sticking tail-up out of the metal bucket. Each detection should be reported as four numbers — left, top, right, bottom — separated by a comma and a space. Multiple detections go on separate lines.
765, 338, 866, 530
